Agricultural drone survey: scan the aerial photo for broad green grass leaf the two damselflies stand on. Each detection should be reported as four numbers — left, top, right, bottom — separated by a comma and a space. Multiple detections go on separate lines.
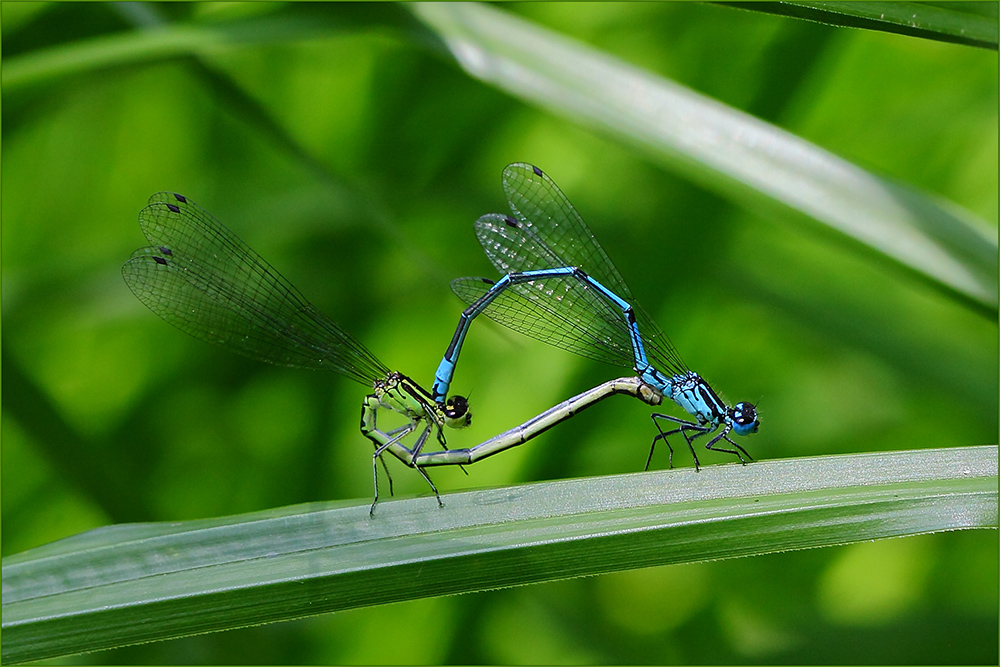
2, 446, 997, 662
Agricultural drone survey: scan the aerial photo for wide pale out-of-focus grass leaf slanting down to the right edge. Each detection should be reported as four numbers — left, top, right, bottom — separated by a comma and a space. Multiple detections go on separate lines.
407, 3, 998, 317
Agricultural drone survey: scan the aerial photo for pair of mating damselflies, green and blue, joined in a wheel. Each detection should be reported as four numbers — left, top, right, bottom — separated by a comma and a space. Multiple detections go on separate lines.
122, 163, 759, 513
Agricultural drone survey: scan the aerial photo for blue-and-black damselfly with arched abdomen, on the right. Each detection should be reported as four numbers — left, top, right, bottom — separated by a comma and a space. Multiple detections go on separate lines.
432, 163, 759, 469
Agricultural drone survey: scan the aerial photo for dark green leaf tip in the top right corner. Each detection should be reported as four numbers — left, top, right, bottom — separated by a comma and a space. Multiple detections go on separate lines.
719, 2, 997, 51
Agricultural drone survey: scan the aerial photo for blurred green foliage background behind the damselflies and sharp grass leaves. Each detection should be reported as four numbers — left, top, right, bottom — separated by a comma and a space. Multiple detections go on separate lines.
0, 3, 998, 664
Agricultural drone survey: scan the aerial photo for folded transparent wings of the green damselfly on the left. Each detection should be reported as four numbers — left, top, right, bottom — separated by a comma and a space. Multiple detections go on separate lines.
122, 192, 389, 386
